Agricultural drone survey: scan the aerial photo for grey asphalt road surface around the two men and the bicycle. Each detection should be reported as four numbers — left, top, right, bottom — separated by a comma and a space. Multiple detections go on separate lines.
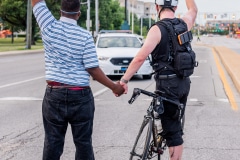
0, 37, 240, 160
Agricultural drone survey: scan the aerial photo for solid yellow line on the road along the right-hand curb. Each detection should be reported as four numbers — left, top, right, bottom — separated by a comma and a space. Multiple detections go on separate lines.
212, 48, 238, 111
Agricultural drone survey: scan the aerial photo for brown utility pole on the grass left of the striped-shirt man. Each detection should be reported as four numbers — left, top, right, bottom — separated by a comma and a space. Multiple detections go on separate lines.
26, 0, 32, 49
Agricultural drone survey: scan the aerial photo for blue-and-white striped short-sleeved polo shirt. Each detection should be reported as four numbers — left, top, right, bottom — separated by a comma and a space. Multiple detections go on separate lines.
33, 1, 99, 86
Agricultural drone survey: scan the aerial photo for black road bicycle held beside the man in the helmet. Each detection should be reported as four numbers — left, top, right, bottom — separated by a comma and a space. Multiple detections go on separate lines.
128, 88, 184, 160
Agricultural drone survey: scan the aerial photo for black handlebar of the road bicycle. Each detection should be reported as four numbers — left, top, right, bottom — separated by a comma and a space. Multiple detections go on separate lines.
128, 88, 183, 108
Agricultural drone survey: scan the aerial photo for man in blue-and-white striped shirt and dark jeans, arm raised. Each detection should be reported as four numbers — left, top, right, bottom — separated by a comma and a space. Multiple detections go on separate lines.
32, 0, 124, 160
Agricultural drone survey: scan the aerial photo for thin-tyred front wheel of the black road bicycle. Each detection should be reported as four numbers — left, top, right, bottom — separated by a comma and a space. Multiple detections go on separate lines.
130, 118, 153, 160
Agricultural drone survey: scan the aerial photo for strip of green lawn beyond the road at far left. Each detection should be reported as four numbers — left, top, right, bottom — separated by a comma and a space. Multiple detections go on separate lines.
0, 38, 43, 52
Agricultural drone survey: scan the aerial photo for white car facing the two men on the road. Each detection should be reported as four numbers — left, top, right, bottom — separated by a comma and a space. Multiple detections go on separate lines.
96, 33, 152, 79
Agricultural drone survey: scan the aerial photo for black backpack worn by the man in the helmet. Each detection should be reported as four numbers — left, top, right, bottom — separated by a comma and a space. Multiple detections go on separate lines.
152, 19, 198, 78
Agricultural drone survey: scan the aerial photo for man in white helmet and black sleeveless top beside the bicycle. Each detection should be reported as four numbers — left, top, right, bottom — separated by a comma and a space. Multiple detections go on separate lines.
120, 0, 198, 160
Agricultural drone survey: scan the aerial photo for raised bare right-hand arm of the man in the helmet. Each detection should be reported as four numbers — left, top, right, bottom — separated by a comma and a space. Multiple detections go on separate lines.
182, 0, 198, 30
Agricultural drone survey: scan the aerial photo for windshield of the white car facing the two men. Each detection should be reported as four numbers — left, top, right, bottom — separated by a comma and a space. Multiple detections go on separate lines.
97, 36, 142, 48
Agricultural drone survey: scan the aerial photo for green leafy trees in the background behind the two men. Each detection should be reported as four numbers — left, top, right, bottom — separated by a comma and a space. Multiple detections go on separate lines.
0, 0, 154, 44
